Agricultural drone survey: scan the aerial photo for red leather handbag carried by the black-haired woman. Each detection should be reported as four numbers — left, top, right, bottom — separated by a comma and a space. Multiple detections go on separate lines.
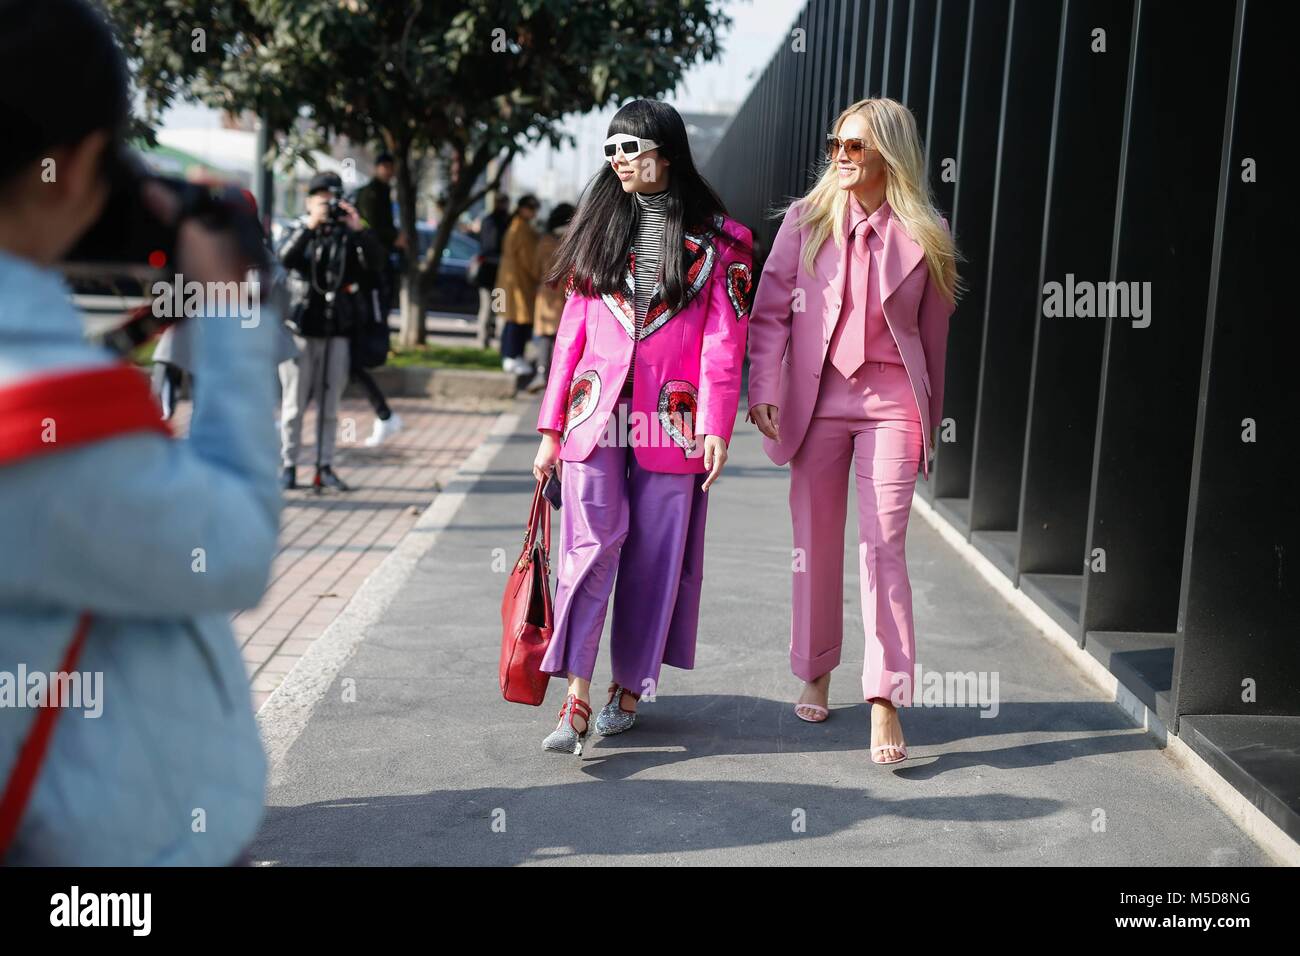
501, 481, 553, 706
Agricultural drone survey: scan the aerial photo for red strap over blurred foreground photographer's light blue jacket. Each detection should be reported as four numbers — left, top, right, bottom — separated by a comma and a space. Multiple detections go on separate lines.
0, 365, 172, 860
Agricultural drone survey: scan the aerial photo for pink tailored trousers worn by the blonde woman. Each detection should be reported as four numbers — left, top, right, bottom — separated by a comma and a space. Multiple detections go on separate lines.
790, 362, 924, 706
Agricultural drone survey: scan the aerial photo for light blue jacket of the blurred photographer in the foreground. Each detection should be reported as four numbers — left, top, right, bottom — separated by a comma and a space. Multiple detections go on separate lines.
0, 252, 280, 865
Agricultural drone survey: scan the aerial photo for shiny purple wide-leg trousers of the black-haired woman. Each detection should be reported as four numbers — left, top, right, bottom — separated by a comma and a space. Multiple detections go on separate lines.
542, 399, 709, 696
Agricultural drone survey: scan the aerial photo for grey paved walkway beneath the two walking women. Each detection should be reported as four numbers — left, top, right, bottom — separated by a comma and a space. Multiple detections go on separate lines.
254, 401, 1271, 866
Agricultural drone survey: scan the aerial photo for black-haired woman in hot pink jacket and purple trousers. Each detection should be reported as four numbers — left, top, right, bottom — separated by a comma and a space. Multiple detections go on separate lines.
533, 100, 751, 753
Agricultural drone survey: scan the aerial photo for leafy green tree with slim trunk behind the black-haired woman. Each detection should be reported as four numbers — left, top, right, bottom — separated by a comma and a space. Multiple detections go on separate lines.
99, 0, 729, 345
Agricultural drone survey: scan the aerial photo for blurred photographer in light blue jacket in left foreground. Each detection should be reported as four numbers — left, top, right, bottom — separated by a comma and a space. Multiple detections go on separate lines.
0, 0, 280, 865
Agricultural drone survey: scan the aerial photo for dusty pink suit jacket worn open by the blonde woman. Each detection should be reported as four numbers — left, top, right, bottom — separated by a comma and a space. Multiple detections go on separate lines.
749, 200, 953, 481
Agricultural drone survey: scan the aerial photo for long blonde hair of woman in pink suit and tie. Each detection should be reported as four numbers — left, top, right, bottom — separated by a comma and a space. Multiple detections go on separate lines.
790, 98, 962, 302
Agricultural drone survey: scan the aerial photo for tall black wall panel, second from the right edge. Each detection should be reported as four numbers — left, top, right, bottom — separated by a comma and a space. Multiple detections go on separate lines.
1082, 0, 1232, 642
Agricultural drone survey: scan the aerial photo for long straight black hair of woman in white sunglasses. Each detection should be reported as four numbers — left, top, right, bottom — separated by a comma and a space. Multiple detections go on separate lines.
546, 100, 727, 308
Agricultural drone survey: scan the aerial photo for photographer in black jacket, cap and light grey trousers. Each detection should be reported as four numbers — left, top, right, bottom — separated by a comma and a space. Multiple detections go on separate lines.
280, 173, 385, 490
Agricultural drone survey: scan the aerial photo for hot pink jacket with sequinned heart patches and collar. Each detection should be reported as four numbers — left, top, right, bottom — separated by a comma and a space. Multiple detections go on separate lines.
537, 216, 753, 475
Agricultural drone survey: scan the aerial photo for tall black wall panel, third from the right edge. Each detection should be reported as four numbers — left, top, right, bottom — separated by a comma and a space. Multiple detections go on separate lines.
1017, 0, 1134, 637
